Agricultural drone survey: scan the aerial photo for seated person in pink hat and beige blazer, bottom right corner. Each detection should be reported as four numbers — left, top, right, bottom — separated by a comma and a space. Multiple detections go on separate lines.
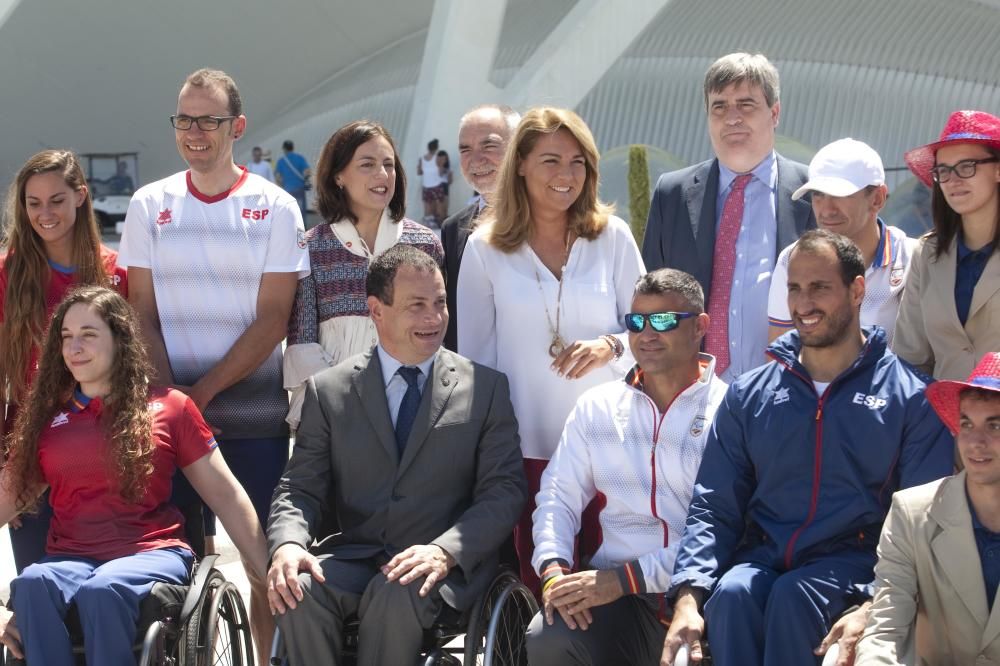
854, 350, 1000, 666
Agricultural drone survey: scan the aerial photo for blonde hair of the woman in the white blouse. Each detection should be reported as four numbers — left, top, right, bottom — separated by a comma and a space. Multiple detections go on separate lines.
484, 107, 614, 252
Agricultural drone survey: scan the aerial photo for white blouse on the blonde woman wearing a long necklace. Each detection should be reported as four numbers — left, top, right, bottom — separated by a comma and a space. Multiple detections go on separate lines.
458, 217, 646, 460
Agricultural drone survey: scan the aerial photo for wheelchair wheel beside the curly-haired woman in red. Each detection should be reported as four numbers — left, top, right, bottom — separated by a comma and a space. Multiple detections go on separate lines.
182, 571, 254, 666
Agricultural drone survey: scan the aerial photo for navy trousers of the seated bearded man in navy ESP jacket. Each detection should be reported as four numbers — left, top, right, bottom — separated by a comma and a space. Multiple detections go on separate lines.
705, 551, 874, 666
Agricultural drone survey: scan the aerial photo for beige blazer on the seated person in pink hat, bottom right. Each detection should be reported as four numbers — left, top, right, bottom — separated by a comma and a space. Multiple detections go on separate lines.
854, 472, 1000, 666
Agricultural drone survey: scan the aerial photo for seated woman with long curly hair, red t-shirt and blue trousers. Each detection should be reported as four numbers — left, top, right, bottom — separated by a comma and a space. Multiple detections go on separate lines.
0, 287, 267, 666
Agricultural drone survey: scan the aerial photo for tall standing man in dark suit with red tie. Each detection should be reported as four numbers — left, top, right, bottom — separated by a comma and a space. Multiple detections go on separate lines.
642, 53, 816, 381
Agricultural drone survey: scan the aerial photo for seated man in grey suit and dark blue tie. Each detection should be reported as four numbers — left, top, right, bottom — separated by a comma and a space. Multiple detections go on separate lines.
267, 244, 526, 666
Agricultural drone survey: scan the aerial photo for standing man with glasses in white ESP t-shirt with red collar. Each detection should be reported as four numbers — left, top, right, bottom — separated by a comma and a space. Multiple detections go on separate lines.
119, 69, 309, 660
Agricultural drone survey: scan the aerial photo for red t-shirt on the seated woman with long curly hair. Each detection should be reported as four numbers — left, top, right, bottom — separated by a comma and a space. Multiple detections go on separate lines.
38, 388, 217, 560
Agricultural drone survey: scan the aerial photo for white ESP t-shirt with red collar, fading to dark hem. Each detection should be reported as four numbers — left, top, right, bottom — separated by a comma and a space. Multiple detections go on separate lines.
118, 171, 309, 439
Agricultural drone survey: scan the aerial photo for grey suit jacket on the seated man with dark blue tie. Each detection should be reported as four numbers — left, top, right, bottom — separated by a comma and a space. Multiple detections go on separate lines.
267, 349, 527, 610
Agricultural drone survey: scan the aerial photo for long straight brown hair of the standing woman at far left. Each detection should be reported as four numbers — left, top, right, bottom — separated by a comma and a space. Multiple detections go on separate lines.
0, 150, 108, 403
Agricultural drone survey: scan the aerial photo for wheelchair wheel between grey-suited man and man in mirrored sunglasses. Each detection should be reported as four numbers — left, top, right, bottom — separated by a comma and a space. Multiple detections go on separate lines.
463, 571, 538, 666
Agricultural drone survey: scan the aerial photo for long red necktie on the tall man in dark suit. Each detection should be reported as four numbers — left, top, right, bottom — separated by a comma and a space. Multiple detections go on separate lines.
705, 173, 752, 375
